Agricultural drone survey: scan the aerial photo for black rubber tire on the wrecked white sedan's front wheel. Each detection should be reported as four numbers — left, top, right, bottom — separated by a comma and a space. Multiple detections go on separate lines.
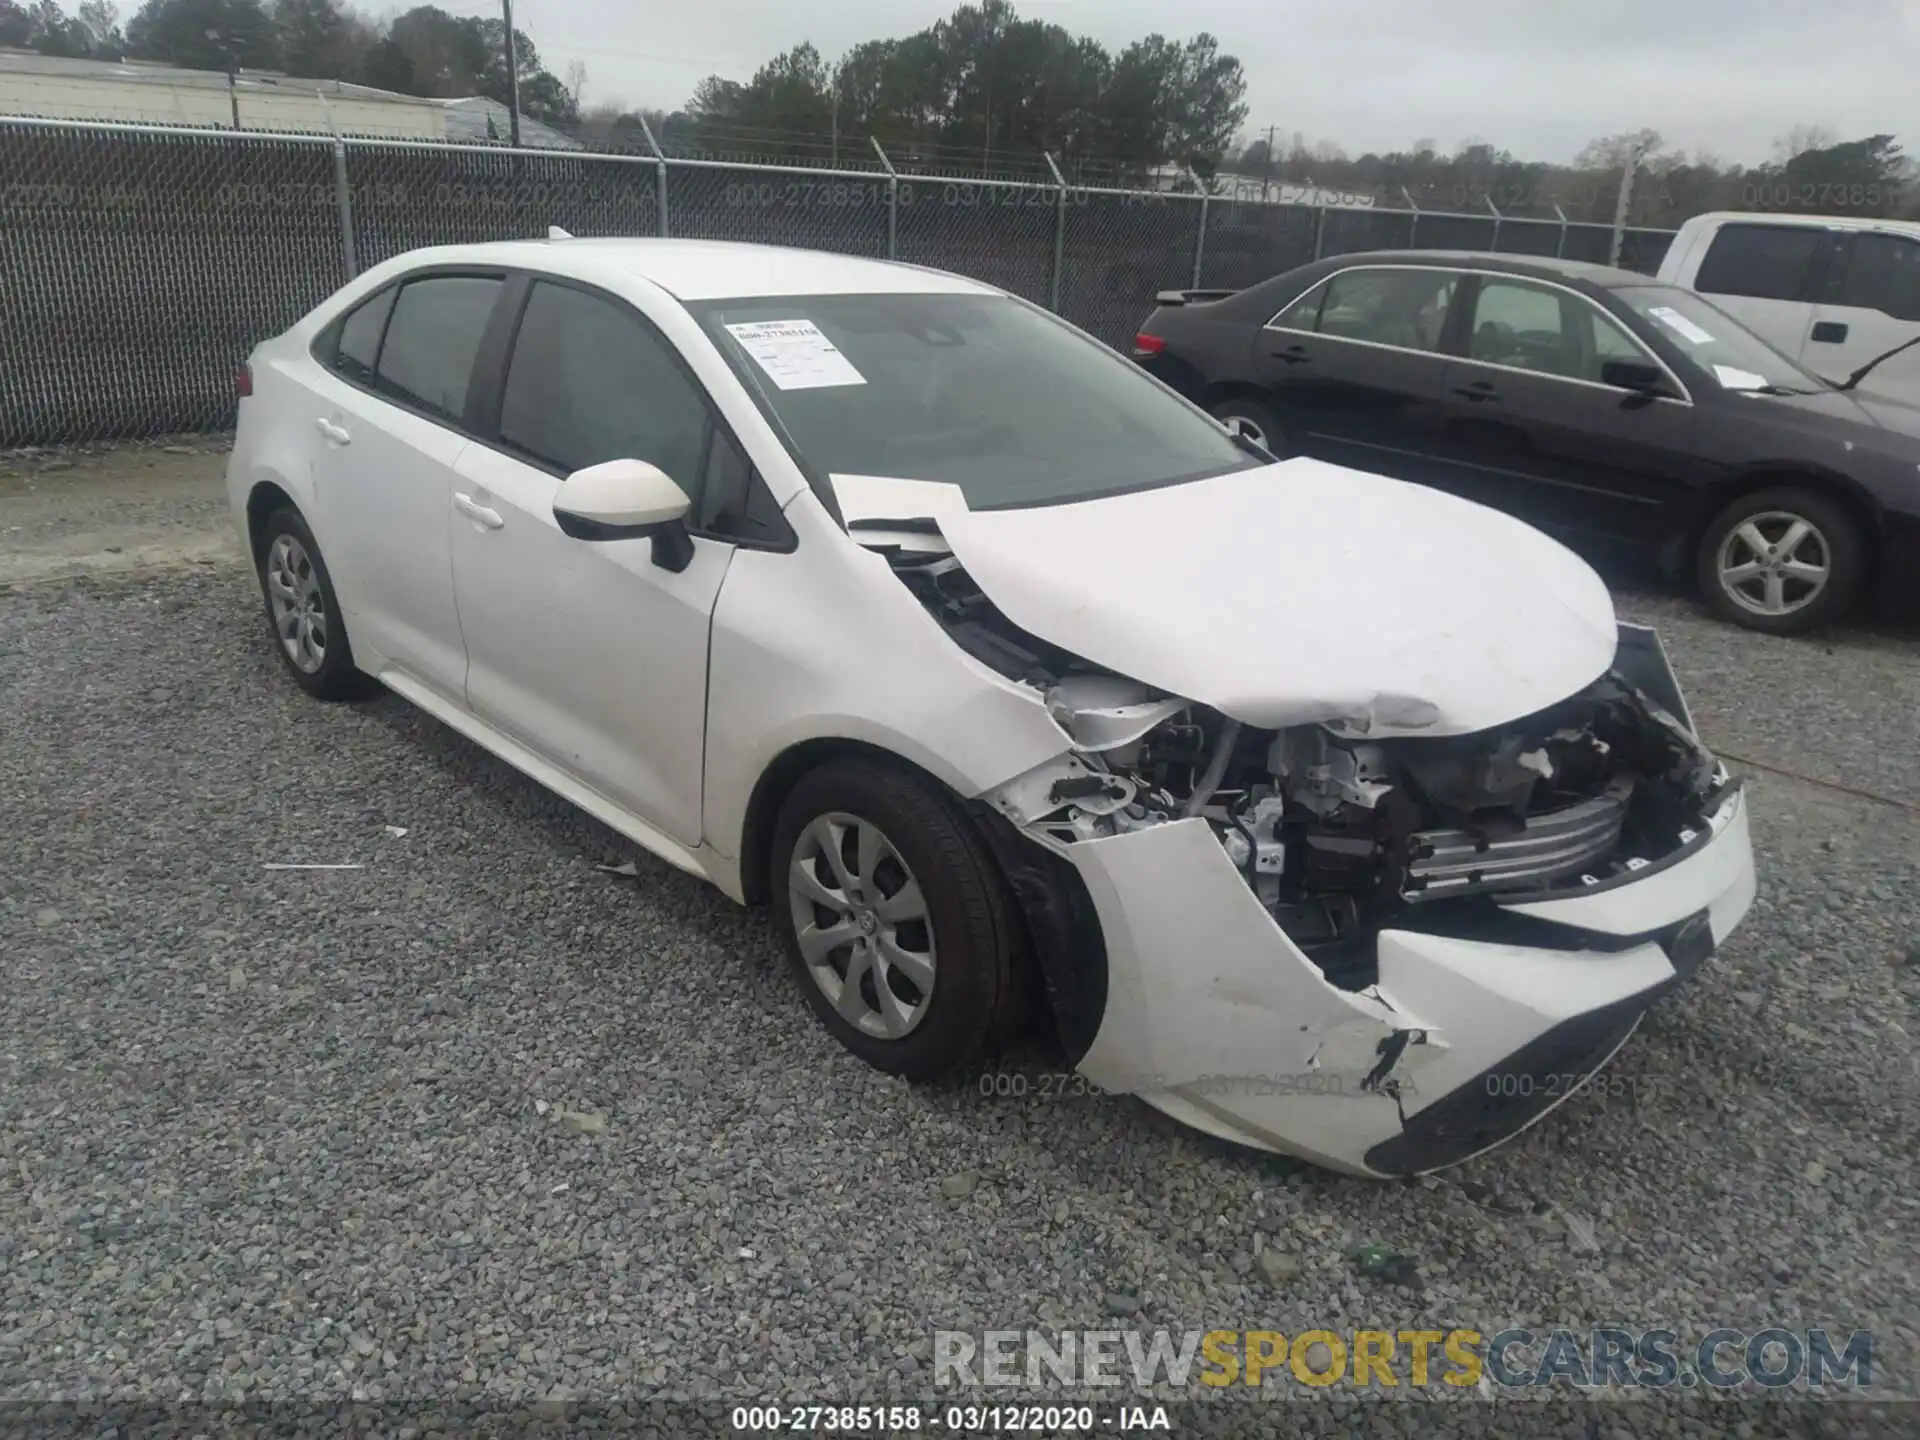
768, 758, 1021, 1081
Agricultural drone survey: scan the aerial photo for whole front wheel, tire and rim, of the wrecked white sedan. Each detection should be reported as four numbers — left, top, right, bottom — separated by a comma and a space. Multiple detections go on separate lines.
768, 760, 1020, 1081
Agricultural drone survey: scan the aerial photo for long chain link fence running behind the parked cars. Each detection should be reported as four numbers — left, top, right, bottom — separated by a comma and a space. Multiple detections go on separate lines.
0, 117, 1672, 447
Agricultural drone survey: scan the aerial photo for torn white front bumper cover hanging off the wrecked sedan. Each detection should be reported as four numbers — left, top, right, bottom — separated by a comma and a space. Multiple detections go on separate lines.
1062, 793, 1753, 1175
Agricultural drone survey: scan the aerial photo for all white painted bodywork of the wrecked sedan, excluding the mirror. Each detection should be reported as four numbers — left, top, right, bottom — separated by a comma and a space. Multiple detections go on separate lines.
228, 240, 1755, 1173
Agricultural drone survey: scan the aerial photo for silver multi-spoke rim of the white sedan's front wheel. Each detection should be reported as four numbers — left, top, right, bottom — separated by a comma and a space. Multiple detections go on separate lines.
787, 810, 935, 1041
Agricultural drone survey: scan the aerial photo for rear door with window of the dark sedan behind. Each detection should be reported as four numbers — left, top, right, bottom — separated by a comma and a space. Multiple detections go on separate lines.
1256, 265, 1459, 480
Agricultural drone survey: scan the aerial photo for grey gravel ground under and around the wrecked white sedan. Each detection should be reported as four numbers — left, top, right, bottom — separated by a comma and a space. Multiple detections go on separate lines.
0, 564, 1920, 1434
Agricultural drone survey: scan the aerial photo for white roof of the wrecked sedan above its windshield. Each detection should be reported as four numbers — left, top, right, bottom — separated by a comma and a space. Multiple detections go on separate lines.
362, 236, 1002, 300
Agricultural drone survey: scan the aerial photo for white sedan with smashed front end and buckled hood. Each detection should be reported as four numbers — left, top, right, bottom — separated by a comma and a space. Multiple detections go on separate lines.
228, 234, 1753, 1175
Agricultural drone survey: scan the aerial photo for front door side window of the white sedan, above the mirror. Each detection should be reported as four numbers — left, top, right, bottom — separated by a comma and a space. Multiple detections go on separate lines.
499, 282, 707, 495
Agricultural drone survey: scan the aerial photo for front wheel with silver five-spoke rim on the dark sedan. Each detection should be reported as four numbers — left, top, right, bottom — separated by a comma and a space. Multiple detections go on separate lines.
1699, 488, 1866, 636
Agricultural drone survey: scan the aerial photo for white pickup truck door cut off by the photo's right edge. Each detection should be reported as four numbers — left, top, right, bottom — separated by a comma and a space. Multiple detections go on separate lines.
1788, 230, 1920, 399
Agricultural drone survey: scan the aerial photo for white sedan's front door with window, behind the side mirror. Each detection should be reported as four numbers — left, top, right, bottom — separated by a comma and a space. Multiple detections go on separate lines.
451, 278, 771, 847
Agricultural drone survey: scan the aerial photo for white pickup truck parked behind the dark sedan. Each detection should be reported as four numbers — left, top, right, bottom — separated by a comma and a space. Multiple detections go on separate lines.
1661, 211, 1920, 403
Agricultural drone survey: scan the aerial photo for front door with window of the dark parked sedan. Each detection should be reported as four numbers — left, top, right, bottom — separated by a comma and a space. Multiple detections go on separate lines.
1444, 275, 1697, 541
